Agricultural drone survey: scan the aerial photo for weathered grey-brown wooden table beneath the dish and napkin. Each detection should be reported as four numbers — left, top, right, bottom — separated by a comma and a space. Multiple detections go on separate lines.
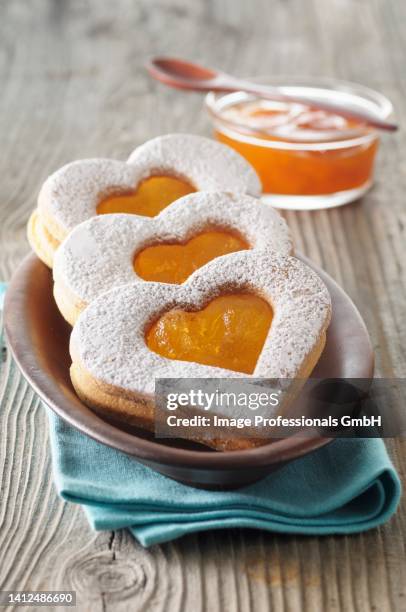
0, 0, 406, 612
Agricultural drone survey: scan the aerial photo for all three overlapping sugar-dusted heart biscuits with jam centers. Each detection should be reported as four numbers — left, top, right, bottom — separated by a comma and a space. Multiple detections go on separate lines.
28, 134, 331, 450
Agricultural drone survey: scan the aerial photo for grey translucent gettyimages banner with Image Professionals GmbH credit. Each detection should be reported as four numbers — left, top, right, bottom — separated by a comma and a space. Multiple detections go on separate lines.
155, 378, 406, 440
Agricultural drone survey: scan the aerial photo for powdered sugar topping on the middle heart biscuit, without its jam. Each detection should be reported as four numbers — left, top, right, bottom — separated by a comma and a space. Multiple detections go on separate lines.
54, 192, 292, 303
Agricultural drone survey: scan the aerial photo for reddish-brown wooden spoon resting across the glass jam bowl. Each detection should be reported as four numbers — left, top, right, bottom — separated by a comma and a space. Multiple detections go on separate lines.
147, 57, 398, 132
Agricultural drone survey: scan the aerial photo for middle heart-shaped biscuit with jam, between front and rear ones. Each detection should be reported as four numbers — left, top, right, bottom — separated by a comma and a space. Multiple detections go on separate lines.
53, 192, 292, 325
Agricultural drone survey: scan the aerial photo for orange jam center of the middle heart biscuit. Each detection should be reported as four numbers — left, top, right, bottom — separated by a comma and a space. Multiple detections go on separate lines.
134, 230, 249, 284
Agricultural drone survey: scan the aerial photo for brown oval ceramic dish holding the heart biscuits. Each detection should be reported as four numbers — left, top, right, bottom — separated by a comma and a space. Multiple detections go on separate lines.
4, 255, 373, 488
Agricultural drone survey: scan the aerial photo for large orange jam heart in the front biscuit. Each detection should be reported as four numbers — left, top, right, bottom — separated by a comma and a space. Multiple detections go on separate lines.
146, 293, 273, 374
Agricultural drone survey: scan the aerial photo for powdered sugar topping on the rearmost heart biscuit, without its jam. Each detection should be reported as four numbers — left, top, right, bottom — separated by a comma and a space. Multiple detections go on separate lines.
38, 134, 261, 240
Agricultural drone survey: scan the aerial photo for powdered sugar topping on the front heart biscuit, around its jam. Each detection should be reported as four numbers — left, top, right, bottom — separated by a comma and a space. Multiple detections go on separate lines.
70, 250, 331, 396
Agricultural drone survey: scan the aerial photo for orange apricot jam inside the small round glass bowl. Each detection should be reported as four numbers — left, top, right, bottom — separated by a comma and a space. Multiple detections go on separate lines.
215, 100, 378, 196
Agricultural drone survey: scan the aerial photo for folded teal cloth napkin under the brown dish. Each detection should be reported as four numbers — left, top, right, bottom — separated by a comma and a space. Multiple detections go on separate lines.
0, 284, 401, 546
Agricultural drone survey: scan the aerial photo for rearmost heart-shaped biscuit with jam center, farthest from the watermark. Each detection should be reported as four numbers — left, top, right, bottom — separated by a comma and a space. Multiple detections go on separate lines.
28, 134, 261, 267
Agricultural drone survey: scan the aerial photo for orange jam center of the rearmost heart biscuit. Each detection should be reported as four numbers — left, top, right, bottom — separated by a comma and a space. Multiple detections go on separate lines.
97, 176, 196, 217
